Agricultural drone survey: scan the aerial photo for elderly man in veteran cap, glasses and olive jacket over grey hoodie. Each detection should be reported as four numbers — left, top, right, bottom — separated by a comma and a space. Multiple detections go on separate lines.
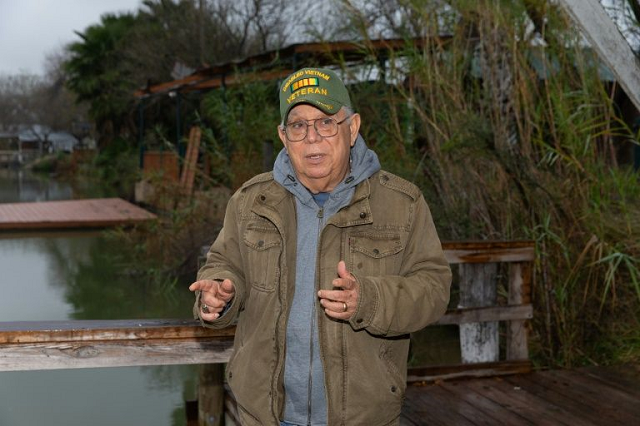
190, 68, 451, 426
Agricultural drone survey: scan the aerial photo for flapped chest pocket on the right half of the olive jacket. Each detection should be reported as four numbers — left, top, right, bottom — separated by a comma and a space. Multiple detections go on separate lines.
349, 233, 404, 275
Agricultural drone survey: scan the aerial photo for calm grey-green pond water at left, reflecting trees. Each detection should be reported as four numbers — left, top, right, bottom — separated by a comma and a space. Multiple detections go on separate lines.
0, 170, 197, 426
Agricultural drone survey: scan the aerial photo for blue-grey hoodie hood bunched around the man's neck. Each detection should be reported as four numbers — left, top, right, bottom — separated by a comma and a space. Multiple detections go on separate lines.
273, 134, 380, 204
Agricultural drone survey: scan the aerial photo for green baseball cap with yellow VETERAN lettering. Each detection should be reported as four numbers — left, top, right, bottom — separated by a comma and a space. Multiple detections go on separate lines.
280, 68, 351, 121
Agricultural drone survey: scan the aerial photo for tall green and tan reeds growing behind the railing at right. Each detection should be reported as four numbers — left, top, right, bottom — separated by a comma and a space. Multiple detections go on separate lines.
336, 0, 640, 366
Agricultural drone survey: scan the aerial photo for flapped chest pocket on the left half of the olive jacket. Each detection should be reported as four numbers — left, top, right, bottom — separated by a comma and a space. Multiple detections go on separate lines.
243, 227, 282, 291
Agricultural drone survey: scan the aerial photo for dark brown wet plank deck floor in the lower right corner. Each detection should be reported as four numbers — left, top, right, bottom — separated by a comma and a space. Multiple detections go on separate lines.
401, 365, 640, 426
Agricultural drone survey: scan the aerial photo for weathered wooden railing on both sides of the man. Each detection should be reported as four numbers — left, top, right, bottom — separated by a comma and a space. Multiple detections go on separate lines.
0, 241, 534, 422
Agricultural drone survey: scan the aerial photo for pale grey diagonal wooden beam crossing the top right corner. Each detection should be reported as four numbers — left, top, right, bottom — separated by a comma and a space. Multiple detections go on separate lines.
560, 0, 640, 111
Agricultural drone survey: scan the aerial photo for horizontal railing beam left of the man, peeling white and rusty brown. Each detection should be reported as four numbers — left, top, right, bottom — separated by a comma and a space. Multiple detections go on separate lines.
0, 320, 235, 371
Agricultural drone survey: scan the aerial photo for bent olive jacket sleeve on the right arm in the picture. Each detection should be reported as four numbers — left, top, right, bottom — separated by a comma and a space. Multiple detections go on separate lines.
349, 195, 451, 337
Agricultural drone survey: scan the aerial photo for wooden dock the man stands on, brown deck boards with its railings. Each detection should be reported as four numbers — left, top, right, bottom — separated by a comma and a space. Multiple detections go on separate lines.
6, 242, 640, 426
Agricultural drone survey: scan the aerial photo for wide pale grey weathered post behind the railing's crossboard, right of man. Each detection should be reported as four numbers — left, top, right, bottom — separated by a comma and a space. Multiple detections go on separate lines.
458, 263, 500, 364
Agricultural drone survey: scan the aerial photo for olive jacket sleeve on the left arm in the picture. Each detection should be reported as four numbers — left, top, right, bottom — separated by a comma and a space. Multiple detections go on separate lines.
193, 192, 246, 329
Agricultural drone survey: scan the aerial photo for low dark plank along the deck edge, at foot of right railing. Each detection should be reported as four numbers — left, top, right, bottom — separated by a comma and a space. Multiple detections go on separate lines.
407, 360, 531, 383
